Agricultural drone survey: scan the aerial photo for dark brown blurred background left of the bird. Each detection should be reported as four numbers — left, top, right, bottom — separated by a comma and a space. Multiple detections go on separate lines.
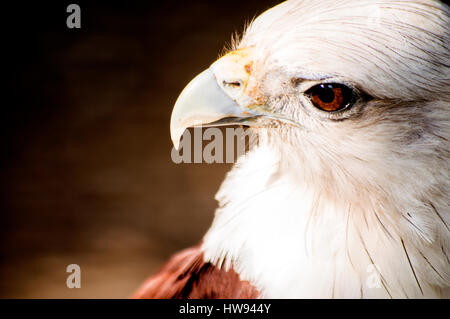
0, 0, 278, 298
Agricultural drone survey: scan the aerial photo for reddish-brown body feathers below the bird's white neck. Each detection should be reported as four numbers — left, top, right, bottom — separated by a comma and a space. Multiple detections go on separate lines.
132, 247, 258, 299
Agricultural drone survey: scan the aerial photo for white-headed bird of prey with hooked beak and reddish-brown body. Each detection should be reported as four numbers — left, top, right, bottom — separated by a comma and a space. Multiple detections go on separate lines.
134, 0, 450, 298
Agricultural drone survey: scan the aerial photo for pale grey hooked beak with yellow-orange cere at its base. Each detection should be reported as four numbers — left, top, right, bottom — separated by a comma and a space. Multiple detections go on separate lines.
170, 48, 298, 149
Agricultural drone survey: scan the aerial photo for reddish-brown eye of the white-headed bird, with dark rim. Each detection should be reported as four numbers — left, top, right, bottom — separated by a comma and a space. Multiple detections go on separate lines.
305, 83, 355, 112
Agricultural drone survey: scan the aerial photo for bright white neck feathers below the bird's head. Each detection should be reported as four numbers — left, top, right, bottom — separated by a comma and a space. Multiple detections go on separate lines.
203, 147, 448, 298
